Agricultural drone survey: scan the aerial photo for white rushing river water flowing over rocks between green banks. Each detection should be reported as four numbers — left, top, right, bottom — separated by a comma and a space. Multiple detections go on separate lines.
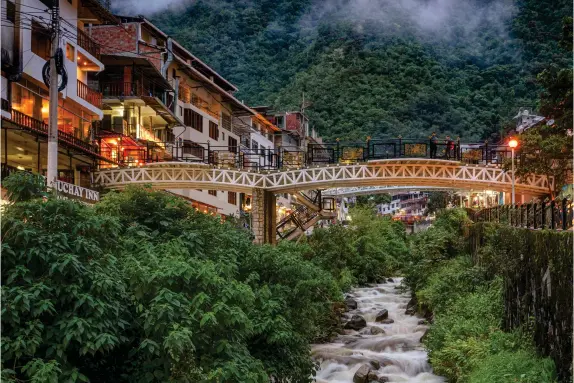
312, 278, 445, 383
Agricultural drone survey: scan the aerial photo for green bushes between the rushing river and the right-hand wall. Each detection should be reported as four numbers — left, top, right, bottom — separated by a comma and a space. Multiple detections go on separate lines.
405, 210, 556, 383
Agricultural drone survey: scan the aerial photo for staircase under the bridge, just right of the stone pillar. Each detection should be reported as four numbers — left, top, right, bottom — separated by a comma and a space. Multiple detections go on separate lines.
276, 190, 337, 240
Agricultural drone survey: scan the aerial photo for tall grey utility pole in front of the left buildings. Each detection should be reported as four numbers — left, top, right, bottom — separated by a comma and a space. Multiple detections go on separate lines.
47, 0, 60, 188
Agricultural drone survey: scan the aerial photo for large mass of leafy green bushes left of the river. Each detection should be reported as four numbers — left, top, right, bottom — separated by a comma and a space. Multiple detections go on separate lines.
2, 173, 407, 383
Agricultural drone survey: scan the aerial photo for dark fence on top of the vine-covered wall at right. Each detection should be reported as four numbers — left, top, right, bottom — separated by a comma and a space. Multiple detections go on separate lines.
473, 198, 574, 230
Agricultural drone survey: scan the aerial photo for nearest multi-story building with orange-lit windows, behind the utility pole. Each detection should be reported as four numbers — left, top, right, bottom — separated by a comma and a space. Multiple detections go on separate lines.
1, 0, 118, 186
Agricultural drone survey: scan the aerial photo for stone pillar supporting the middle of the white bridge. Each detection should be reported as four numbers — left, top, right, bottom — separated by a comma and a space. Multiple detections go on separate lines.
251, 189, 277, 244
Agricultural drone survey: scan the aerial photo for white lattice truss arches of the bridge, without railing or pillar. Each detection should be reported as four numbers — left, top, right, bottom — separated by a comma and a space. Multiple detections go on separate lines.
94, 159, 552, 196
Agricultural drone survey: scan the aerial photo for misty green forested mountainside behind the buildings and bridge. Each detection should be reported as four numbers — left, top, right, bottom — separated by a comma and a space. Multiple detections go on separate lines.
150, 0, 572, 140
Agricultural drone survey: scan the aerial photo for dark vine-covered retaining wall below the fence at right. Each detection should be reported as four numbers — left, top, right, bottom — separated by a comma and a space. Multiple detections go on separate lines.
469, 222, 573, 382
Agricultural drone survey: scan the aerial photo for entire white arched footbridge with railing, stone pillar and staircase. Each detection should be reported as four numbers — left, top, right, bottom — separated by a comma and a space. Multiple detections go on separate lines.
94, 138, 553, 243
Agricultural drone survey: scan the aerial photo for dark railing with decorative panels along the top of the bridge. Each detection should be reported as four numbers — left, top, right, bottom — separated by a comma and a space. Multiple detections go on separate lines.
97, 138, 520, 170
